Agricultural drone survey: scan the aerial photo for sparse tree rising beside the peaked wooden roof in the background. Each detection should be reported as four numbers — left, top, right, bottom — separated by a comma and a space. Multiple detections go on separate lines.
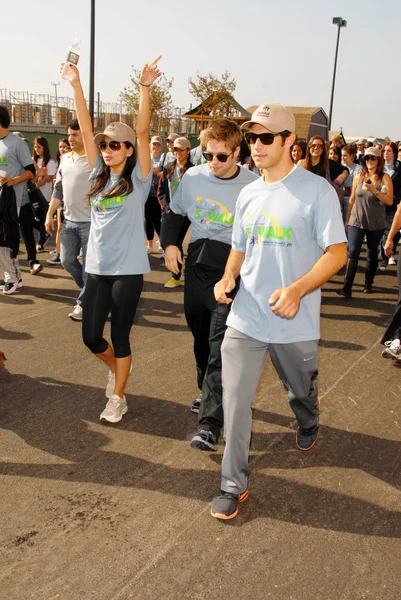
188, 70, 237, 117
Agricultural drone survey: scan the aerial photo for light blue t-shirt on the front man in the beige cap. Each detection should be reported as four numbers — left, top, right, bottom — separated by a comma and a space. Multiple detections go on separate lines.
227, 166, 346, 344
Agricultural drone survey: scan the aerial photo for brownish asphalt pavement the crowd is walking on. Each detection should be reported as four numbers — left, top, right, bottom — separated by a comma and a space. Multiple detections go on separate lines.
0, 244, 401, 600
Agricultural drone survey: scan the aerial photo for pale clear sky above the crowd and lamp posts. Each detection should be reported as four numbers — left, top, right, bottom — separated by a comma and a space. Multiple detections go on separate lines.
0, 0, 401, 140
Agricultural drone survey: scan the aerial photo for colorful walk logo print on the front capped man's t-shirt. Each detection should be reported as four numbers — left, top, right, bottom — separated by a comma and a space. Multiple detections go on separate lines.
243, 212, 293, 248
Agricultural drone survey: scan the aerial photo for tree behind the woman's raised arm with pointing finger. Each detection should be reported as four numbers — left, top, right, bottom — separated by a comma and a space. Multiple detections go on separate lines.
121, 66, 174, 134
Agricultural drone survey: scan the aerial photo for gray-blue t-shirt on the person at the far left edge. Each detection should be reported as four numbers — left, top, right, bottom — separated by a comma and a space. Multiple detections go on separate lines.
0, 133, 33, 210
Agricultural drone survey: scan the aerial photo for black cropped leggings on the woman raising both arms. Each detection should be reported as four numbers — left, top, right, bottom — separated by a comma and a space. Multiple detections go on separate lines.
82, 273, 143, 358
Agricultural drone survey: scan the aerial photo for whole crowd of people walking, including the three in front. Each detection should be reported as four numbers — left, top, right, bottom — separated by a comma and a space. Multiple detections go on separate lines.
0, 57, 401, 520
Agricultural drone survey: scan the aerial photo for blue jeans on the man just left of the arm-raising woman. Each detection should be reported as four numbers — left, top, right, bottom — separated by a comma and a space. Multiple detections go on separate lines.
60, 219, 90, 306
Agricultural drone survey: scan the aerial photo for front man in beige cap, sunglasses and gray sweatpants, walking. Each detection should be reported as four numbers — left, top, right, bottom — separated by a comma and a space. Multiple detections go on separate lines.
212, 104, 347, 520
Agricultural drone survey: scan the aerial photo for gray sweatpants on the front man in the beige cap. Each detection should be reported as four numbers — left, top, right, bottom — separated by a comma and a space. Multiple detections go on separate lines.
221, 327, 319, 494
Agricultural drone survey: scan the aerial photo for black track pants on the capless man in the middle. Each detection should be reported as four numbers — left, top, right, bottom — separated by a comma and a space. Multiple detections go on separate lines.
184, 265, 238, 438
